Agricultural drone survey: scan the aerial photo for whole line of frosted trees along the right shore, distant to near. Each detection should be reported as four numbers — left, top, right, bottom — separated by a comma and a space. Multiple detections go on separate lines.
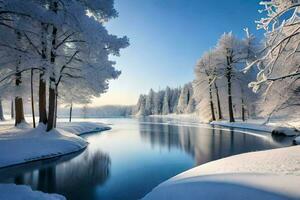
136, 0, 300, 122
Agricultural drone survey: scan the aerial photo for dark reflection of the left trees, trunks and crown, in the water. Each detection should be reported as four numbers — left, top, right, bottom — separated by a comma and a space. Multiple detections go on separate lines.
11, 151, 111, 200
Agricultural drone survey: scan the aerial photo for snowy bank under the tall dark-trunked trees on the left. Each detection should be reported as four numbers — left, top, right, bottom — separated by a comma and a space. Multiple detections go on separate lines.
0, 122, 108, 167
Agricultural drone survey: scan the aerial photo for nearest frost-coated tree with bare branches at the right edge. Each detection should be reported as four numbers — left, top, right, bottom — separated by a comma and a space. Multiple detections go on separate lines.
245, 0, 300, 120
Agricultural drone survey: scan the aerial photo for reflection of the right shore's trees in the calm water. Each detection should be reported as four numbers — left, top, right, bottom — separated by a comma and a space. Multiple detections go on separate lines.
139, 119, 284, 166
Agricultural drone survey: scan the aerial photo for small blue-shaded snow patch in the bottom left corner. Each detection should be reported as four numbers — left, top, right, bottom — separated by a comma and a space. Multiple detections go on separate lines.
0, 184, 66, 200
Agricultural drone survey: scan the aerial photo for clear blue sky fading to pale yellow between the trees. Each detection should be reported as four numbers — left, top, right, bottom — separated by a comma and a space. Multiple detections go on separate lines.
93, 0, 262, 105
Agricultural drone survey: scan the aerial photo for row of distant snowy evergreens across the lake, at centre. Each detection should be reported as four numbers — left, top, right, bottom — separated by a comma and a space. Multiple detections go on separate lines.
133, 83, 196, 116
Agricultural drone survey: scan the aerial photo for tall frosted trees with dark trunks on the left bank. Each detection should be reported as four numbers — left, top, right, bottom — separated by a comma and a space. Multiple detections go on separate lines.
0, 0, 129, 131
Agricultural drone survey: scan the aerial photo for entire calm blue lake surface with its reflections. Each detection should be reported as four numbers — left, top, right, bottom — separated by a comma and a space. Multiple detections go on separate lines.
0, 118, 292, 200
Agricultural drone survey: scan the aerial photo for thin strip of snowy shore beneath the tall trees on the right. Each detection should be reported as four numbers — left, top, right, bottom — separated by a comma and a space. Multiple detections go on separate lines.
210, 120, 299, 136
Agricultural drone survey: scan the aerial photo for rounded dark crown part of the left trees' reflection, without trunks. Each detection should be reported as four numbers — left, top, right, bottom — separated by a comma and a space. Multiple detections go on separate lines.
56, 151, 111, 199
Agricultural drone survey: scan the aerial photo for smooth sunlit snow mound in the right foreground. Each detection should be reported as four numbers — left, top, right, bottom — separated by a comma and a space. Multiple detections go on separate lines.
144, 146, 300, 200
